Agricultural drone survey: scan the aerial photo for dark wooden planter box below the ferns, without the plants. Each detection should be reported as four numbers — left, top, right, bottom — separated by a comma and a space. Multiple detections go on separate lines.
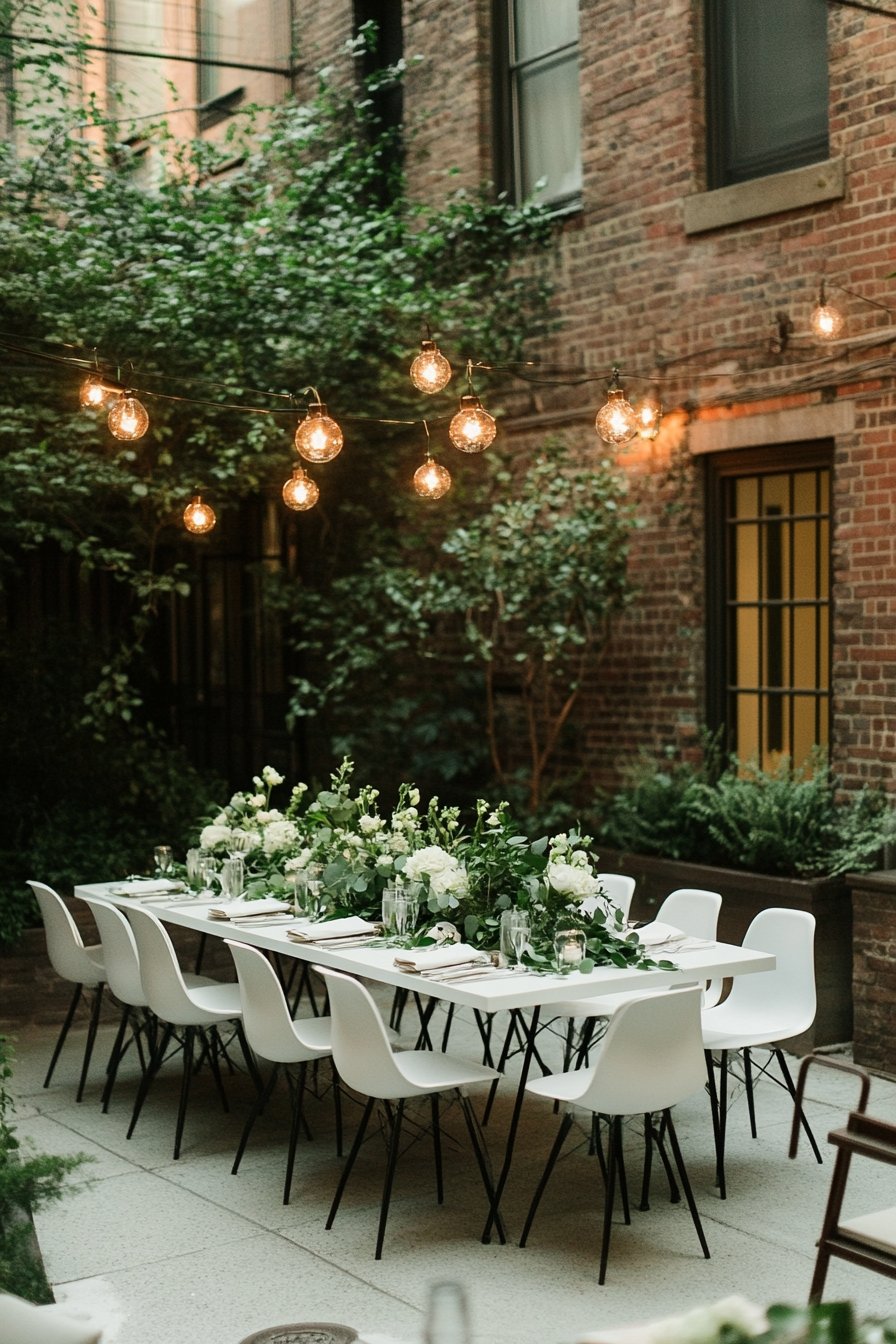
598, 848, 853, 1054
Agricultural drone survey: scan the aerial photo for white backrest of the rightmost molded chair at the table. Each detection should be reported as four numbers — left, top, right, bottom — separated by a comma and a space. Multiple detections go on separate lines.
717, 906, 815, 1040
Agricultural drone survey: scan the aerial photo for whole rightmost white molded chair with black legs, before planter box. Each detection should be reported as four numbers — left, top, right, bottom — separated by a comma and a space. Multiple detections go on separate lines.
703, 906, 821, 1199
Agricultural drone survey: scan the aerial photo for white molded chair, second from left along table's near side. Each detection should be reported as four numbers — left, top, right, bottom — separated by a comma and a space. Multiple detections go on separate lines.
81, 896, 216, 1111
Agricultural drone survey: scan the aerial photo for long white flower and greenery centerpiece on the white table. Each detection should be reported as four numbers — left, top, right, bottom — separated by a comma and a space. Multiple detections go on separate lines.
197, 759, 671, 972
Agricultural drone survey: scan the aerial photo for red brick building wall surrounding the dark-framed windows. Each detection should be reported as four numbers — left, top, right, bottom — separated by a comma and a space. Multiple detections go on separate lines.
298, 0, 896, 786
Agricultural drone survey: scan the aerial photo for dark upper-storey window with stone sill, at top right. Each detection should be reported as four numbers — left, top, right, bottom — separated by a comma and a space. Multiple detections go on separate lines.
705, 0, 829, 188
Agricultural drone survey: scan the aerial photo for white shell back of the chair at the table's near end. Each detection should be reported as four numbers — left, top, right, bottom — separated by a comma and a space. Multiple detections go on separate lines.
570, 977, 709, 1116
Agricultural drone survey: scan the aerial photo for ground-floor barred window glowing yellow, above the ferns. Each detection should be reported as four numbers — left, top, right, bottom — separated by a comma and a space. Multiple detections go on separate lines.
707, 445, 832, 769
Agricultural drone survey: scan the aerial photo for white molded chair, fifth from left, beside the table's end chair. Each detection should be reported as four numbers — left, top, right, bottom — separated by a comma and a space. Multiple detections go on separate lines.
317, 966, 505, 1259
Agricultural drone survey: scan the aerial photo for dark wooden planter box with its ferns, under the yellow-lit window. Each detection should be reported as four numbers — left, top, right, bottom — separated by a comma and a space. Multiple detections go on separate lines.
592, 743, 893, 1050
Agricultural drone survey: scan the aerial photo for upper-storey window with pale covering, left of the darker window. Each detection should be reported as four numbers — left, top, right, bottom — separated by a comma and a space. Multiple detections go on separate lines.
493, 0, 582, 208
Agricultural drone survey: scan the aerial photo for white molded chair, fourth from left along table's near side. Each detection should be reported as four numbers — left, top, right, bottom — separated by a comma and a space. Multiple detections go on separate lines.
224, 938, 343, 1204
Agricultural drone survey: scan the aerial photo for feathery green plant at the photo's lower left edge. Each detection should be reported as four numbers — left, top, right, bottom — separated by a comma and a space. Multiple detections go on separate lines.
0, 1036, 90, 1302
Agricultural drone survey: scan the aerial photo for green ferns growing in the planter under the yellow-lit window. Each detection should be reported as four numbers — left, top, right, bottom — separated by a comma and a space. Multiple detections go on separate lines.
595, 749, 895, 878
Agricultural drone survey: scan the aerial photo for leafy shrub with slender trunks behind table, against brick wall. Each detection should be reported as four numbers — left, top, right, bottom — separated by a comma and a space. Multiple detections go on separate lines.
279, 444, 634, 812
